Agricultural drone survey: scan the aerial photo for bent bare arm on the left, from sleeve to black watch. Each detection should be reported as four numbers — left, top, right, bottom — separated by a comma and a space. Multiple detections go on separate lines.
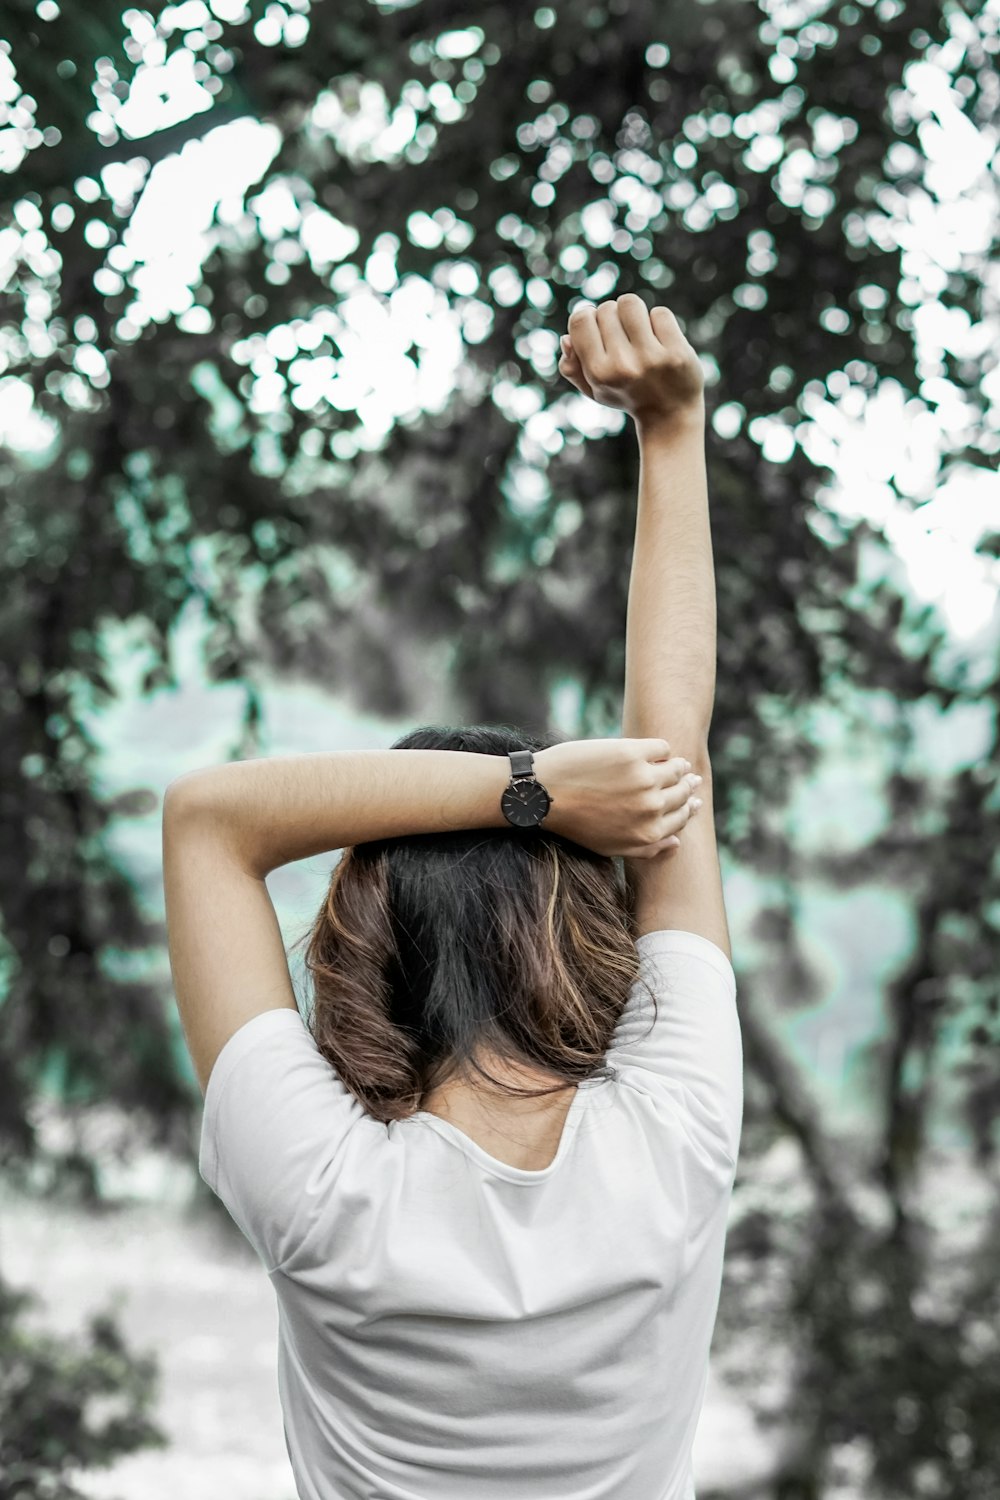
163, 750, 510, 1092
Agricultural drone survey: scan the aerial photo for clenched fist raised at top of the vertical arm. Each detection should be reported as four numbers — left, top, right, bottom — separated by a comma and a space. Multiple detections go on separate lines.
559, 291, 705, 425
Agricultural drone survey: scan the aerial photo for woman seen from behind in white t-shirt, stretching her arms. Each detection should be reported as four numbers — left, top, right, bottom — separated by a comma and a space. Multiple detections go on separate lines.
163, 296, 742, 1500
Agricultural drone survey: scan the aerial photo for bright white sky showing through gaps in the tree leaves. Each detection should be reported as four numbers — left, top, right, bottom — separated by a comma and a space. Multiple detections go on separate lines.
0, 0, 1000, 647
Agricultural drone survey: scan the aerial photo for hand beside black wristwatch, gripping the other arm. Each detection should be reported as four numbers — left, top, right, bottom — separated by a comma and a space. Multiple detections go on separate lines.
534, 740, 700, 860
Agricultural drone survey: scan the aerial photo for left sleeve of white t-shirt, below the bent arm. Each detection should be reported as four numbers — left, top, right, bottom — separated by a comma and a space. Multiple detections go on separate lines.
198, 1007, 364, 1274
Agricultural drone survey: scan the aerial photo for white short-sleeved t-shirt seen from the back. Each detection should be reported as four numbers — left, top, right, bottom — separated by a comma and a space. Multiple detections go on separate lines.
198, 929, 744, 1500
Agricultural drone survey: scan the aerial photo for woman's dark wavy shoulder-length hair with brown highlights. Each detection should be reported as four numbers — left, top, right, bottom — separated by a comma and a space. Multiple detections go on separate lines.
303, 725, 655, 1122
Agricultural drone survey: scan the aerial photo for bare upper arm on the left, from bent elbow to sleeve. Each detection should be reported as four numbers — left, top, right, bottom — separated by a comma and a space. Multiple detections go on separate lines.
163, 779, 297, 1094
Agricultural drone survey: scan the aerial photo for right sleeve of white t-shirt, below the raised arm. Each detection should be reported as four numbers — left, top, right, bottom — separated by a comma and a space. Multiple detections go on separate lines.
607, 927, 744, 1172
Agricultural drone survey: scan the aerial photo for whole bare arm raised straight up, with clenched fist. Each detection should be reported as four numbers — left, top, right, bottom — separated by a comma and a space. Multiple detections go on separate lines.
561, 294, 732, 960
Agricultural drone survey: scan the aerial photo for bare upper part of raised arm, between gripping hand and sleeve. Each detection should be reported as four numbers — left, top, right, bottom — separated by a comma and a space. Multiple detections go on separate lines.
625, 756, 733, 963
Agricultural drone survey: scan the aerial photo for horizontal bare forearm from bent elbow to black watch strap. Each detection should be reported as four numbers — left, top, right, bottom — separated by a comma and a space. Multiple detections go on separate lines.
163, 750, 510, 876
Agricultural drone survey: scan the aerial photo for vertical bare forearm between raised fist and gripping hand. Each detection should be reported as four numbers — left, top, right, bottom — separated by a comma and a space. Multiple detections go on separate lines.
622, 405, 717, 761
